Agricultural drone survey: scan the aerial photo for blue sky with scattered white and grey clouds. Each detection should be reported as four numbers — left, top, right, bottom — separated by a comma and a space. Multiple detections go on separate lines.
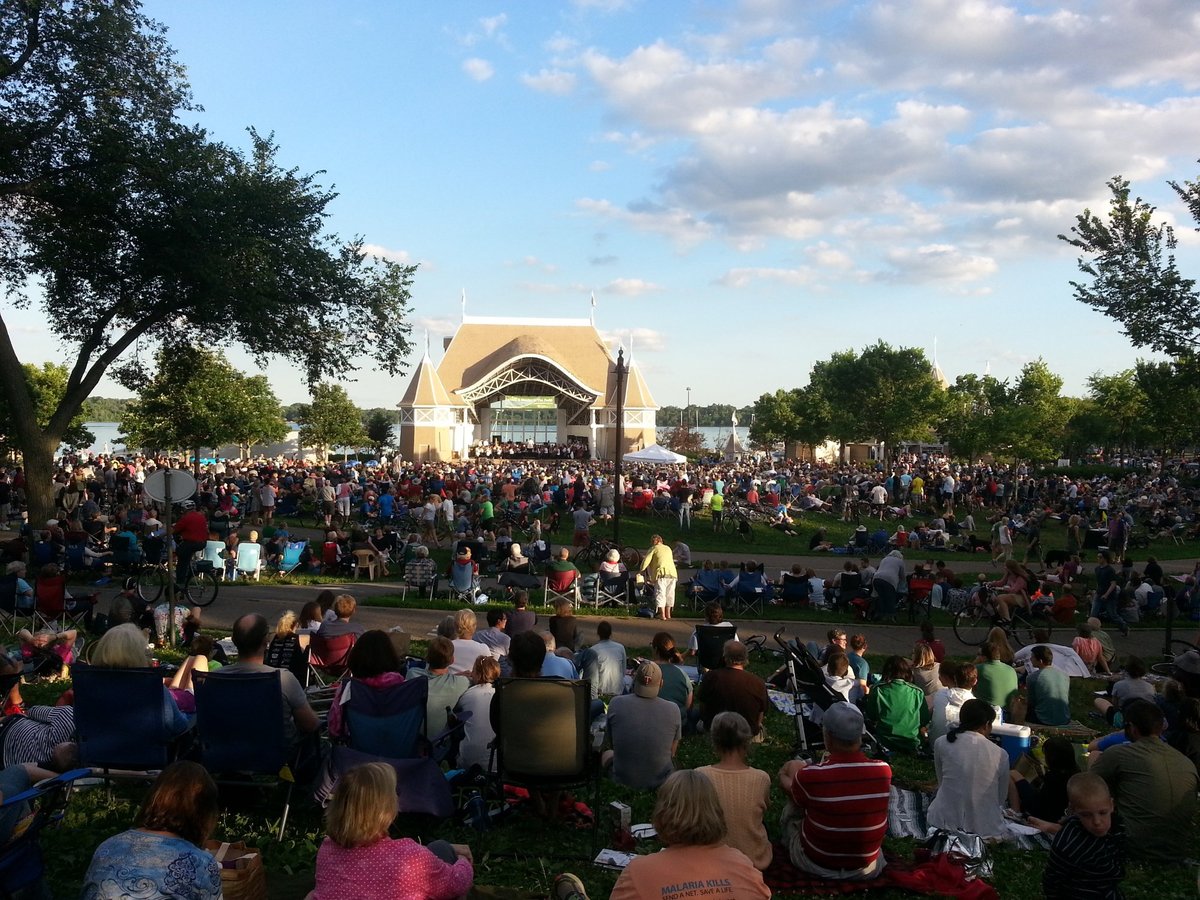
5, 0, 1200, 407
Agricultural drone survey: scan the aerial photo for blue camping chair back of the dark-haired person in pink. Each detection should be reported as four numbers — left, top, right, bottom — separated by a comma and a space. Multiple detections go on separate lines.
342, 678, 430, 760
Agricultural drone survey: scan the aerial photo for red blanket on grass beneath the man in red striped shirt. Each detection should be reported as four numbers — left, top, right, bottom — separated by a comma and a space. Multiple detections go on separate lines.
762, 844, 998, 900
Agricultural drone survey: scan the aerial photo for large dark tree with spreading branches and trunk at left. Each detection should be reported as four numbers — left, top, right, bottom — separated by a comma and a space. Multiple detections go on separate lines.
0, 7, 415, 521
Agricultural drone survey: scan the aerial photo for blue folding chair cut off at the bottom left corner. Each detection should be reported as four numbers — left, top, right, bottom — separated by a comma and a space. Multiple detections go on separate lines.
0, 769, 91, 898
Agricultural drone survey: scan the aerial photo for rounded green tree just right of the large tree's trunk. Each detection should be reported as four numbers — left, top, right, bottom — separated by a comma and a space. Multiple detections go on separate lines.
121, 347, 287, 466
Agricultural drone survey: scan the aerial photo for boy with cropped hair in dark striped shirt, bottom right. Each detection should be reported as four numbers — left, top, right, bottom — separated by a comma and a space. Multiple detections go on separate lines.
1028, 772, 1126, 900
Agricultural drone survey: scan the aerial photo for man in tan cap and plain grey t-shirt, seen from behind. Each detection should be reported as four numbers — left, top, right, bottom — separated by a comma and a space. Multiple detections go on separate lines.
602, 662, 682, 791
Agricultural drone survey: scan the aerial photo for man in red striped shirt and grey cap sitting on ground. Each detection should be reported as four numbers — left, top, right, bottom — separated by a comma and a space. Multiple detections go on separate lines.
779, 701, 892, 881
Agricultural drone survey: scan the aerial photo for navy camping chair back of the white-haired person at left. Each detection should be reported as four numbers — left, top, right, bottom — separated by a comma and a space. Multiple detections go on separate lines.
71, 664, 170, 770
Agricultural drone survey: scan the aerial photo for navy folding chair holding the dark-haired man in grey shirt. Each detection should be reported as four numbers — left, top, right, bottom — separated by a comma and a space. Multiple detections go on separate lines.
196, 671, 295, 840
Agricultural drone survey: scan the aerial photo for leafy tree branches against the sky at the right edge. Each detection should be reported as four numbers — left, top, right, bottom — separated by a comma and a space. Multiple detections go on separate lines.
1058, 170, 1200, 354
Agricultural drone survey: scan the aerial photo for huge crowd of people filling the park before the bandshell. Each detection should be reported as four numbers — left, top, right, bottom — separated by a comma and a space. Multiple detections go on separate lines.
0, 448, 1200, 900
